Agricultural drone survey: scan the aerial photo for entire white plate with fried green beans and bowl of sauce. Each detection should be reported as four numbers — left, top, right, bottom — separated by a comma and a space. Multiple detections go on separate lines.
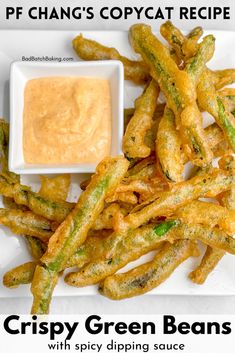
0, 15, 235, 314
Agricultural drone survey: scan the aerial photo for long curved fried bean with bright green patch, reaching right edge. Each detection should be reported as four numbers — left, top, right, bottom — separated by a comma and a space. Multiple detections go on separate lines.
65, 220, 235, 287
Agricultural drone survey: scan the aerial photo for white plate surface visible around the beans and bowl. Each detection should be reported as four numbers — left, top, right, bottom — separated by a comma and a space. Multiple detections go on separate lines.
0, 30, 235, 297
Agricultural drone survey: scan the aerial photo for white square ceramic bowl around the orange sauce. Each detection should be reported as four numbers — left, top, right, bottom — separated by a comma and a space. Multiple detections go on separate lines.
9, 60, 124, 174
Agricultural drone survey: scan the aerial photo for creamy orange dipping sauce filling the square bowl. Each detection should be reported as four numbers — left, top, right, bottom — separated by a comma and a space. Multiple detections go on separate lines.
23, 77, 111, 164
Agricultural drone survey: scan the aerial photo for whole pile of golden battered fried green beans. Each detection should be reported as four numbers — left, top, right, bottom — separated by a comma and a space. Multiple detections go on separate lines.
0, 21, 235, 314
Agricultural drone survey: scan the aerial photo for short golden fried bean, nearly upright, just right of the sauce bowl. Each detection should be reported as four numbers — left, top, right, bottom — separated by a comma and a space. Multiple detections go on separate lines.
122, 80, 159, 158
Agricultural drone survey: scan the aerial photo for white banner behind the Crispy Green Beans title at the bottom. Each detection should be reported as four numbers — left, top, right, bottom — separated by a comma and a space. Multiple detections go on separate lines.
0, 315, 235, 353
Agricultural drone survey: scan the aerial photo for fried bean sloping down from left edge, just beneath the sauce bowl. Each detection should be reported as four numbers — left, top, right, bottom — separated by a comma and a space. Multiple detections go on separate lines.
0, 173, 75, 223
